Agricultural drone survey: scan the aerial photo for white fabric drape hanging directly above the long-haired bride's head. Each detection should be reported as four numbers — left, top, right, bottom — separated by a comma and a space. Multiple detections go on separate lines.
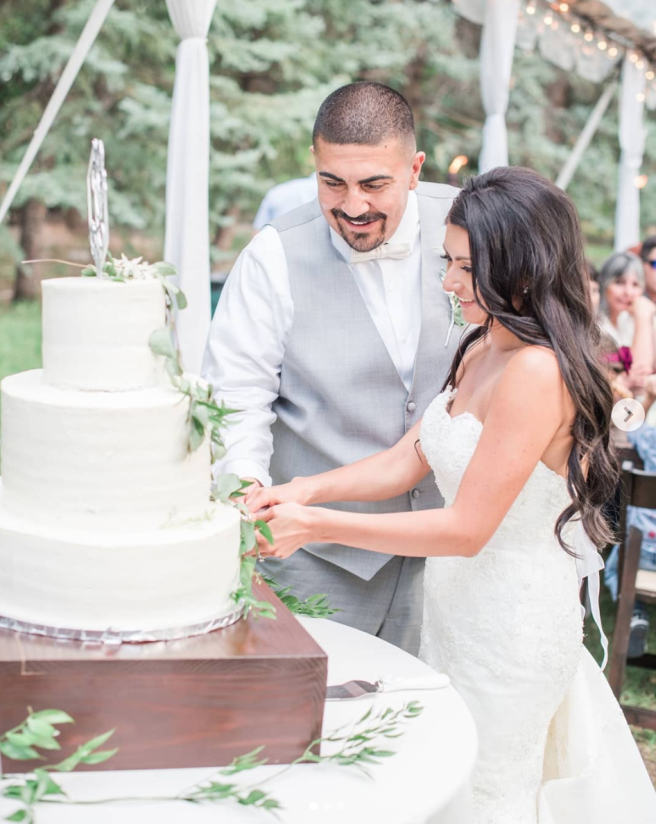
478, 0, 519, 172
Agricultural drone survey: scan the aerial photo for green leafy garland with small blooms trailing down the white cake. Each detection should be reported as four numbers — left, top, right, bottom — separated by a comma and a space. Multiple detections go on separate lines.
81, 253, 338, 618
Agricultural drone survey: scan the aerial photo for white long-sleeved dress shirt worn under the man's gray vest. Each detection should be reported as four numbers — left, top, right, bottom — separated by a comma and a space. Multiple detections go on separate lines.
203, 192, 421, 486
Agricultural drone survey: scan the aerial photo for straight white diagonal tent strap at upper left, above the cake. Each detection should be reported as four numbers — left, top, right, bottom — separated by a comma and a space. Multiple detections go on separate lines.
0, 0, 114, 223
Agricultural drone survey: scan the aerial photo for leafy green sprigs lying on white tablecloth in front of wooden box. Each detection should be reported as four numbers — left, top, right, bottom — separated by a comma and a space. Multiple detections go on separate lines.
0, 701, 423, 824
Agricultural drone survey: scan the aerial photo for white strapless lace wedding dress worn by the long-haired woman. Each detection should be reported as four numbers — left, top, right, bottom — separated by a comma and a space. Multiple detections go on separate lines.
420, 390, 656, 824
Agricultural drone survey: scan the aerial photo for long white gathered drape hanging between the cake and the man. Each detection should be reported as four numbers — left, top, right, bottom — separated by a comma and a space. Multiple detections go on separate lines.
164, 0, 216, 374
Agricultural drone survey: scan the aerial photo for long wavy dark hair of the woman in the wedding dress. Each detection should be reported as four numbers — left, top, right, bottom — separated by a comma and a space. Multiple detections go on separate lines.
444, 167, 618, 551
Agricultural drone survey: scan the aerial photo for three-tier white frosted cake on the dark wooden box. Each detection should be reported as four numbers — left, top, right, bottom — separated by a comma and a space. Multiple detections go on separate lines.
0, 277, 240, 640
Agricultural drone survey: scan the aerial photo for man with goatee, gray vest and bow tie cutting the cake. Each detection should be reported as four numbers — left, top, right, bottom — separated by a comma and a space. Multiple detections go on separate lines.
203, 82, 458, 655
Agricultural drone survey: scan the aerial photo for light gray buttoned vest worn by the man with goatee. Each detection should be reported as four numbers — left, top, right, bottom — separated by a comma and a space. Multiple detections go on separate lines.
270, 183, 459, 580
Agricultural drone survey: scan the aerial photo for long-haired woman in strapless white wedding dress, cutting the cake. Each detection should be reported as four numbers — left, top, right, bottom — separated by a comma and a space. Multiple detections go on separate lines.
248, 168, 656, 824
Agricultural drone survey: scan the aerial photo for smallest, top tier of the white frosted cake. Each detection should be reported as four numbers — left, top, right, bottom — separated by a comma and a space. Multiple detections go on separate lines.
42, 276, 166, 391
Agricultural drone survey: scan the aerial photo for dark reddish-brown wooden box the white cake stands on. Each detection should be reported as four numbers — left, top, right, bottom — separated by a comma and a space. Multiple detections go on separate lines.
0, 584, 328, 773
